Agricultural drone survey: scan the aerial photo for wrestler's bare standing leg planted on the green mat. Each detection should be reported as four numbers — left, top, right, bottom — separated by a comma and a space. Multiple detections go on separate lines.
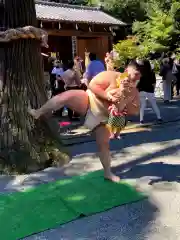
95, 125, 120, 182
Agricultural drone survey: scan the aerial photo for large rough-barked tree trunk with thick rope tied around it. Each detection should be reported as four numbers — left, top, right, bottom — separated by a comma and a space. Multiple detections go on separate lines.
0, 0, 69, 172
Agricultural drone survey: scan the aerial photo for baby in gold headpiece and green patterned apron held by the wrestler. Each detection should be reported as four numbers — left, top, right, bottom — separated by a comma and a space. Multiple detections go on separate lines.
107, 72, 137, 139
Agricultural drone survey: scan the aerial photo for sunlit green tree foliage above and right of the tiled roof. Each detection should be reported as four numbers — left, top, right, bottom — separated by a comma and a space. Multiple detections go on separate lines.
51, 0, 180, 58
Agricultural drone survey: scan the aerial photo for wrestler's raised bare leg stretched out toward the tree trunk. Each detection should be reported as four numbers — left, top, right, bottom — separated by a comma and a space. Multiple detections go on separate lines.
29, 90, 89, 119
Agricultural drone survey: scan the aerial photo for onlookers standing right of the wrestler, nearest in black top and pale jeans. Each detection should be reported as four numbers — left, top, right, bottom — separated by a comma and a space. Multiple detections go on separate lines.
137, 53, 180, 124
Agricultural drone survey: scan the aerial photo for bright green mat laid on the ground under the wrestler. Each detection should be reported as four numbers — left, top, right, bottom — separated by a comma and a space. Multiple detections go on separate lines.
0, 171, 144, 240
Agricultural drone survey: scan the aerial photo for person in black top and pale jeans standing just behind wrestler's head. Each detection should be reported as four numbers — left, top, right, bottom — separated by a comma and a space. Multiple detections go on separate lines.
137, 60, 162, 124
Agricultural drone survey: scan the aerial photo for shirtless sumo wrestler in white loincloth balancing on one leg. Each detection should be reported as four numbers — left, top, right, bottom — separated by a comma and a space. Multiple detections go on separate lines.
30, 62, 141, 182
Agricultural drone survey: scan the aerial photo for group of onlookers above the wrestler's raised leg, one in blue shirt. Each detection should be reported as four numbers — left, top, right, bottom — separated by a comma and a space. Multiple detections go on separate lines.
49, 53, 105, 121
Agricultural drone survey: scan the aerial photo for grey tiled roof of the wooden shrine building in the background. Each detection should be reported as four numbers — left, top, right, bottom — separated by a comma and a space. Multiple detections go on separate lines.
36, 1, 126, 26
